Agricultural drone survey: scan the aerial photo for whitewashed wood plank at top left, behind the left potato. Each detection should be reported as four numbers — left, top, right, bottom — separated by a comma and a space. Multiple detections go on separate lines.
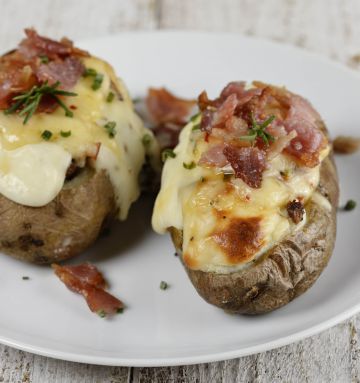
0, 0, 157, 51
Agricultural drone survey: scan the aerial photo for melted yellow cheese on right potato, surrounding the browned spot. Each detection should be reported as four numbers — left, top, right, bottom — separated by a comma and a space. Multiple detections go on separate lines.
152, 121, 329, 273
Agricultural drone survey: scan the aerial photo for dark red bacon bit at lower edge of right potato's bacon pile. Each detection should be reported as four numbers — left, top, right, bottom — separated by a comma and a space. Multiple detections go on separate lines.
223, 145, 266, 188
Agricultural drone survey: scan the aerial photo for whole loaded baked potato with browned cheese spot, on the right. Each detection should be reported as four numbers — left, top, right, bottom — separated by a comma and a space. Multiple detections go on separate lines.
152, 82, 339, 314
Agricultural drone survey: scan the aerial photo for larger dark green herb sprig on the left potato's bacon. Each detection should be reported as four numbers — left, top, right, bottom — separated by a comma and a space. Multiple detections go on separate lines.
4, 81, 77, 125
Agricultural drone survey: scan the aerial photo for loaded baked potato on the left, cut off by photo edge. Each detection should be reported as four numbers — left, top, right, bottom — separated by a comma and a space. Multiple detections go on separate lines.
0, 30, 158, 263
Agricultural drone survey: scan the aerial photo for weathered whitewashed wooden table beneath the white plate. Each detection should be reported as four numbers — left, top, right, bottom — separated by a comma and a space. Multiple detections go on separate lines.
0, 0, 360, 383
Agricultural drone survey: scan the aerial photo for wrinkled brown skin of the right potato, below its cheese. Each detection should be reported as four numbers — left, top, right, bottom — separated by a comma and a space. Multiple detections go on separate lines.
169, 155, 339, 314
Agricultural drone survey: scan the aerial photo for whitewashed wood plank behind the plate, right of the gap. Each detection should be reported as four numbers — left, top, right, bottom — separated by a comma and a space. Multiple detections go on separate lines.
159, 0, 360, 62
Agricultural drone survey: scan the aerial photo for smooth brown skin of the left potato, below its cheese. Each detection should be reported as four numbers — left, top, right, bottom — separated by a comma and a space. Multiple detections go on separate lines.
0, 167, 116, 264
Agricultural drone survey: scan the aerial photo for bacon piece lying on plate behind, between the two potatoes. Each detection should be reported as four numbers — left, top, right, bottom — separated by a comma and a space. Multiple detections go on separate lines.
145, 88, 196, 149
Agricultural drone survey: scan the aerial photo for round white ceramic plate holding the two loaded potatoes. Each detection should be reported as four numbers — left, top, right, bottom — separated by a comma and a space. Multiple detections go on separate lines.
0, 32, 360, 366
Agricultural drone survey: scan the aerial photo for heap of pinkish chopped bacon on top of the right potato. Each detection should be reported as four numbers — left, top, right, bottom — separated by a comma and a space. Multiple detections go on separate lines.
198, 82, 327, 174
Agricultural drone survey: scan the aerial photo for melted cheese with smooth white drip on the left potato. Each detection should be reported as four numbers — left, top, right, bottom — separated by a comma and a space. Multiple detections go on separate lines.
0, 57, 158, 219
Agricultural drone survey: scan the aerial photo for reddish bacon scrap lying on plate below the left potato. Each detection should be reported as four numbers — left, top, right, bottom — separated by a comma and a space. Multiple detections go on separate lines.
51, 263, 124, 316
